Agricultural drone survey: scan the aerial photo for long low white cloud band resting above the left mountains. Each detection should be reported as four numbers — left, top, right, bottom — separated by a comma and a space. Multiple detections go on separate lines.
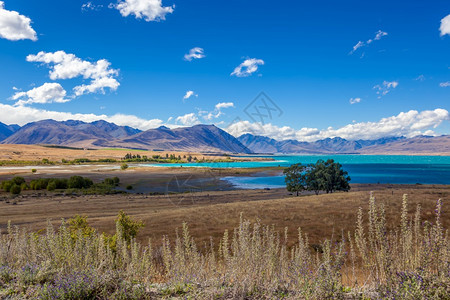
0, 103, 164, 130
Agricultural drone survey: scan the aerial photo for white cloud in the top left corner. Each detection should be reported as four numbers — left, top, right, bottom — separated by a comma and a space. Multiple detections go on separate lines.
0, 1, 37, 41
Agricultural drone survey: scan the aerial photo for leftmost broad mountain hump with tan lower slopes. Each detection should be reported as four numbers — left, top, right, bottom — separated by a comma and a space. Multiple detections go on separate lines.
2, 120, 140, 147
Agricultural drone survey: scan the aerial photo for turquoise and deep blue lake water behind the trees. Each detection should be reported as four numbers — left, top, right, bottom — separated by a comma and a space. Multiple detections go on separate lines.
146, 155, 450, 189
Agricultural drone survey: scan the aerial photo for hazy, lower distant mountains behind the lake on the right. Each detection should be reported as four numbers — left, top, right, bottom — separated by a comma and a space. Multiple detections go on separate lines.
238, 134, 444, 154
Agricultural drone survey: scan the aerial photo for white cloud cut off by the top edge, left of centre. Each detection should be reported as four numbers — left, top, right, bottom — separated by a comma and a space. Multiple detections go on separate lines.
110, 0, 175, 22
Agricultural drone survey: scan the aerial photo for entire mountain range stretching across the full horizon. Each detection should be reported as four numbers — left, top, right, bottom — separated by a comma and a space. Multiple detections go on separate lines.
0, 120, 450, 154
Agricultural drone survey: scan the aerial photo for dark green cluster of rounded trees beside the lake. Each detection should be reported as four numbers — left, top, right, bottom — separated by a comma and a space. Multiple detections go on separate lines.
283, 159, 350, 196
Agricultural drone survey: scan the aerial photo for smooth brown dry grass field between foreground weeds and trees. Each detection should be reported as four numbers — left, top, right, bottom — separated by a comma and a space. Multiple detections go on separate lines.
0, 185, 450, 250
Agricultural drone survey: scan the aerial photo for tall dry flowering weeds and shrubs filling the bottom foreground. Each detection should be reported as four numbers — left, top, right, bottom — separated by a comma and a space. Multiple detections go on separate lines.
0, 193, 450, 299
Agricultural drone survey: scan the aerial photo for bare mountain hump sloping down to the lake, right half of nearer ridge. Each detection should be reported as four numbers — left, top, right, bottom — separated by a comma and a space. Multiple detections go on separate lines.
96, 125, 251, 153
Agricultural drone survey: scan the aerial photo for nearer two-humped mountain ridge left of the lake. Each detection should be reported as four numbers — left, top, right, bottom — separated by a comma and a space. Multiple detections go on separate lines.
1, 120, 251, 153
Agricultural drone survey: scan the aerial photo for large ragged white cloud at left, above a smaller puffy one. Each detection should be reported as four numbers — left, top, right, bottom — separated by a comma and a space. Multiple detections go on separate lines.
27, 51, 120, 96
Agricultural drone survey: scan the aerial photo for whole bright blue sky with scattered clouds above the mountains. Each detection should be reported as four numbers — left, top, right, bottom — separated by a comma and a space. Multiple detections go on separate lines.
0, 0, 450, 140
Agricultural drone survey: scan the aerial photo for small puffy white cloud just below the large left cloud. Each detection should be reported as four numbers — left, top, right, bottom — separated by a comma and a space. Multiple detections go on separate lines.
11, 82, 70, 106
